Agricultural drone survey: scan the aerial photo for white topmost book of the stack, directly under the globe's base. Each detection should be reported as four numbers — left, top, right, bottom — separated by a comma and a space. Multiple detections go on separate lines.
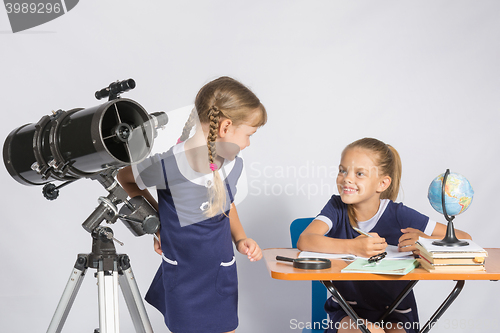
415, 238, 488, 259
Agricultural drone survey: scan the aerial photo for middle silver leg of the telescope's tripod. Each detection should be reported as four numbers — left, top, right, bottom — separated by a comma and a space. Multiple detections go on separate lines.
97, 260, 120, 333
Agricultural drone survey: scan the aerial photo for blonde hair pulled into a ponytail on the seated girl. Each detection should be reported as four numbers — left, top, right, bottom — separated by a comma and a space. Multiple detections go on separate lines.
342, 138, 403, 227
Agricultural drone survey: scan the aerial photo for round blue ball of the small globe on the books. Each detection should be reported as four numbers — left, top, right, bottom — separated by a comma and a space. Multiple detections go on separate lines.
428, 172, 474, 216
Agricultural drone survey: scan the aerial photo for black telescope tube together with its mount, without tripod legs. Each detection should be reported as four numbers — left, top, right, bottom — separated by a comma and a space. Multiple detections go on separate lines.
3, 79, 168, 236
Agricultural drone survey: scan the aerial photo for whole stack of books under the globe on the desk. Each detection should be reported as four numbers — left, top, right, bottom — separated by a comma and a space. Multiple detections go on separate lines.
415, 238, 488, 273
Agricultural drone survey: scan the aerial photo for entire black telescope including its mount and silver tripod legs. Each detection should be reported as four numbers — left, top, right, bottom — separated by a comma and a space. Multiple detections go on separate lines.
3, 79, 168, 333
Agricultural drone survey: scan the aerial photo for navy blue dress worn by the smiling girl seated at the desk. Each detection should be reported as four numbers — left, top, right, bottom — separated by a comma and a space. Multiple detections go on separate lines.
318, 195, 429, 333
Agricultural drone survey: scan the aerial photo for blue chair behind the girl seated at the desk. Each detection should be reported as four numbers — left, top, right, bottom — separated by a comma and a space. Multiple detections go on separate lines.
290, 217, 328, 333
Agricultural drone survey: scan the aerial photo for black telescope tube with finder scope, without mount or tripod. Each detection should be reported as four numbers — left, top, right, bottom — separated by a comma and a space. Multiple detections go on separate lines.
3, 79, 168, 185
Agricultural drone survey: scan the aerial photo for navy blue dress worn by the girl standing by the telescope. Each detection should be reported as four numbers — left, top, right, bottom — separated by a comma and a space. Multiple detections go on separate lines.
133, 144, 243, 333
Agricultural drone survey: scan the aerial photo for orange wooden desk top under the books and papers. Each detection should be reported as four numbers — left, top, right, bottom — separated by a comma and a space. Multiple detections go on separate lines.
263, 248, 500, 281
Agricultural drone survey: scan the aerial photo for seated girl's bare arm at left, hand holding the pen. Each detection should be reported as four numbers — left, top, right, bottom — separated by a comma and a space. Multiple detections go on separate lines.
297, 220, 387, 257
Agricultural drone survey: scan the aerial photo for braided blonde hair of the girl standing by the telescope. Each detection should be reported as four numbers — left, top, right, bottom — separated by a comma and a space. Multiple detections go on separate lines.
179, 76, 267, 217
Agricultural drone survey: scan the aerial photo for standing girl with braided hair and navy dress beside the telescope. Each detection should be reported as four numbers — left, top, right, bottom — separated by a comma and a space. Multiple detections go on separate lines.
118, 77, 267, 333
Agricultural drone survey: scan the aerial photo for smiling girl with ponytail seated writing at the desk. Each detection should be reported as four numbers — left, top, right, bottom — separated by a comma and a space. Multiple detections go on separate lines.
297, 138, 470, 333
